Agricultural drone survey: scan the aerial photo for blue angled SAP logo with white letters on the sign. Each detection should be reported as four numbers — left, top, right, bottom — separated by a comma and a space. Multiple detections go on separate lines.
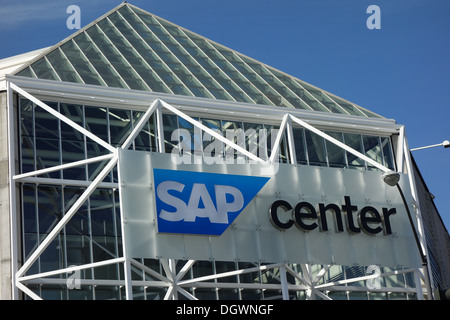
153, 169, 269, 236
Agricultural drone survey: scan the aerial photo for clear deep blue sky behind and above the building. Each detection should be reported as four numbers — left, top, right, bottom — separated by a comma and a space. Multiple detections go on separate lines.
0, 0, 450, 229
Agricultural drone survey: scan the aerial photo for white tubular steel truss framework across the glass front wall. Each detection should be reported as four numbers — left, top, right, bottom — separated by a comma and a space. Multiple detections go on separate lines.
7, 81, 432, 300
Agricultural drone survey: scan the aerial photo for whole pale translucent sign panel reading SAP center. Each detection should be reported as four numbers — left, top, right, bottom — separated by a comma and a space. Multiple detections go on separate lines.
119, 151, 420, 267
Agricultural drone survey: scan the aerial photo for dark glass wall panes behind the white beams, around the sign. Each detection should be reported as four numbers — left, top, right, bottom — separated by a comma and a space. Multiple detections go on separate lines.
14, 98, 416, 299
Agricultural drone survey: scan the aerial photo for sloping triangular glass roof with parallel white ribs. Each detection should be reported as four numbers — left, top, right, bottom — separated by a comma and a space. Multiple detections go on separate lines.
17, 3, 381, 118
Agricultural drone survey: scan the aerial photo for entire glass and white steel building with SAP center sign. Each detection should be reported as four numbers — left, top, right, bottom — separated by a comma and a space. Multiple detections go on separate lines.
0, 3, 450, 300
